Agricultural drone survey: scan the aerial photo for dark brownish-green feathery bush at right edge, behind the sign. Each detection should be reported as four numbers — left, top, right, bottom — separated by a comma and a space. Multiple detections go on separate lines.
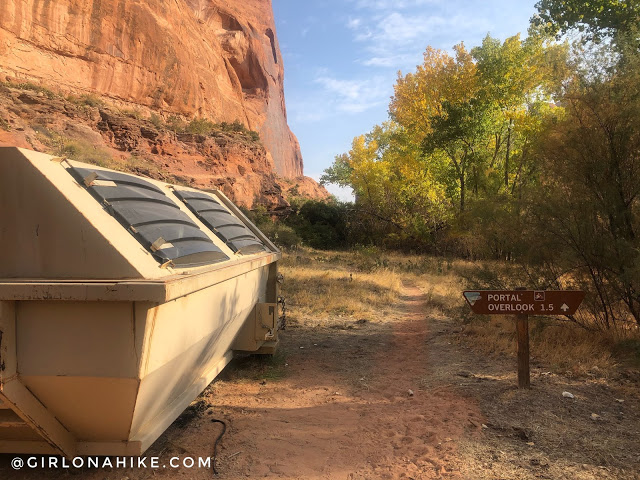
525, 54, 640, 328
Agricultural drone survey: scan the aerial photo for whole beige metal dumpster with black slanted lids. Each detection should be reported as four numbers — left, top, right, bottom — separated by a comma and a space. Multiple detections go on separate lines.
0, 148, 280, 456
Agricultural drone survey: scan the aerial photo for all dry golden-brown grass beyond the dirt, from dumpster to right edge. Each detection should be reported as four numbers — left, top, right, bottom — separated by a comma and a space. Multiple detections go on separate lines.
282, 249, 639, 377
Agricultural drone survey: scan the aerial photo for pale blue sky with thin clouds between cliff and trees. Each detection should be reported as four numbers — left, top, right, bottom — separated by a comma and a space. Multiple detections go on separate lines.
273, 0, 535, 198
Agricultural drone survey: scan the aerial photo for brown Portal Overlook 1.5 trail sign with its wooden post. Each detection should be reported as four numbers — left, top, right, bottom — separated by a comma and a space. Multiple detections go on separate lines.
464, 287, 585, 388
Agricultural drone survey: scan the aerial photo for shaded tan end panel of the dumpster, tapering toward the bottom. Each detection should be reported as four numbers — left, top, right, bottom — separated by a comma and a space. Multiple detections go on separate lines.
16, 301, 144, 441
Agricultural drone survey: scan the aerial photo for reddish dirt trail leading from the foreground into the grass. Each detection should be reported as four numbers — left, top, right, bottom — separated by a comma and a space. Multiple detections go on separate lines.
198, 286, 480, 479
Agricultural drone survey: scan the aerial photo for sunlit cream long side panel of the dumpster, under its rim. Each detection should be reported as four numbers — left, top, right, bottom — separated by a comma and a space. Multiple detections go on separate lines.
132, 265, 269, 439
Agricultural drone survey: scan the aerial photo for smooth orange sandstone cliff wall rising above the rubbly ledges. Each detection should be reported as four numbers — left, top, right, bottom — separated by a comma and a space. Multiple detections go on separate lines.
0, 0, 303, 178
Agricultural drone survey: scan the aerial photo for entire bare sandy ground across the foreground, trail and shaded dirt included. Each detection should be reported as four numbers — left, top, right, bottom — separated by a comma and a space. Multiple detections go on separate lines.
0, 285, 640, 480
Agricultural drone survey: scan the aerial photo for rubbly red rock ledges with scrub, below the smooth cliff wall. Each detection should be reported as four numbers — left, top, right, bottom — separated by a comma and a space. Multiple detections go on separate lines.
0, 83, 329, 210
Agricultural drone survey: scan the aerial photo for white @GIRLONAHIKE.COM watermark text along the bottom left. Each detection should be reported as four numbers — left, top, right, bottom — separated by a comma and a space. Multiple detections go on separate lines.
11, 456, 211, 470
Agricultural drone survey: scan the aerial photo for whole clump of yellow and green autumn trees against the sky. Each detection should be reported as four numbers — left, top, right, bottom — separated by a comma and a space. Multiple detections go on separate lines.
322, 35, 566, 253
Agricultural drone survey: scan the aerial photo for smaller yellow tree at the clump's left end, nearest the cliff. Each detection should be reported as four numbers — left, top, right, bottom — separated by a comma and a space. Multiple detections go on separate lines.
323, 122, 450, 246
